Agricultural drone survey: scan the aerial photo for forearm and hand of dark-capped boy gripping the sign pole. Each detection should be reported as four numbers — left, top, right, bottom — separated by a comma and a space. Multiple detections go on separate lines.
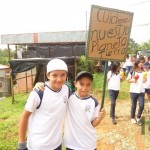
92, 108, 106, 127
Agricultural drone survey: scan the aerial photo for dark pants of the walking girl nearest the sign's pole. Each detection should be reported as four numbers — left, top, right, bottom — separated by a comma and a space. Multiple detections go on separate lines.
108, 90, 119, 118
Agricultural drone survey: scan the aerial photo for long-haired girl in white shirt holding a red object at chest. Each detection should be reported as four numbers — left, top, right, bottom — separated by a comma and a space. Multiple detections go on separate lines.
127, 57, 147, 125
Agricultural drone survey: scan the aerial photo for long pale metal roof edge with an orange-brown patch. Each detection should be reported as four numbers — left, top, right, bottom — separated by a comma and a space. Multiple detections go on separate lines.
1, 31, 87, 44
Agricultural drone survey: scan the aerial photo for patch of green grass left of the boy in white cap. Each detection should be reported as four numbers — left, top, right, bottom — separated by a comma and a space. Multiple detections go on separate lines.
0, 93, 28, 150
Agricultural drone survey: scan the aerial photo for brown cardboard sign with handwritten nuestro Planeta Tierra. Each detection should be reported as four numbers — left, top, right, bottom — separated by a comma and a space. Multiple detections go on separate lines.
88, 5, 133, 60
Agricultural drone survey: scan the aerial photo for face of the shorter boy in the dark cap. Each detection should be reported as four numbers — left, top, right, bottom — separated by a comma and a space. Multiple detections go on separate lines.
74, 77, 92, 98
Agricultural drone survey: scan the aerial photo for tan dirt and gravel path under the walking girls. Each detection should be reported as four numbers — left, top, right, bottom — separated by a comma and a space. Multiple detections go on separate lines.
97, 100, 150, 150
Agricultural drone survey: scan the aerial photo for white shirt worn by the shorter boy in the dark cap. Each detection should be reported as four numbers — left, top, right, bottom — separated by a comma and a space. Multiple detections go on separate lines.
64, 94, 99, 150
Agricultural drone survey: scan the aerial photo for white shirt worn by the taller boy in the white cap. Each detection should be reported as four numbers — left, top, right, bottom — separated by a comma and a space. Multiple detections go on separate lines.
25, 82, 69, 150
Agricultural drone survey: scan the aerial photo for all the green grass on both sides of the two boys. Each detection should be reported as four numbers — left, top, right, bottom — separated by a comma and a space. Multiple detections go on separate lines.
0, 74, 129, 150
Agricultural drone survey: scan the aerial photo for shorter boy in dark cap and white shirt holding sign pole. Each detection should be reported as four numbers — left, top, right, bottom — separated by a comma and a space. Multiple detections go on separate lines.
64, 71, 105, 150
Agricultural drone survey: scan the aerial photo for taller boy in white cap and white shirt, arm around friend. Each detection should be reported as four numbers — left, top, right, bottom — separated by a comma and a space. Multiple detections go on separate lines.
18, 59, 70, 150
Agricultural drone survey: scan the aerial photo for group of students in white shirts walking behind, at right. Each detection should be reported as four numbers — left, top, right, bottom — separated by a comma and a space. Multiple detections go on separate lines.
107, 56, 150, 125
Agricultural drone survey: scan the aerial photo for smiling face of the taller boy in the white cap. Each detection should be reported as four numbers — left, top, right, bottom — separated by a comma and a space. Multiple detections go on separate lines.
47, 70, 67, 91
